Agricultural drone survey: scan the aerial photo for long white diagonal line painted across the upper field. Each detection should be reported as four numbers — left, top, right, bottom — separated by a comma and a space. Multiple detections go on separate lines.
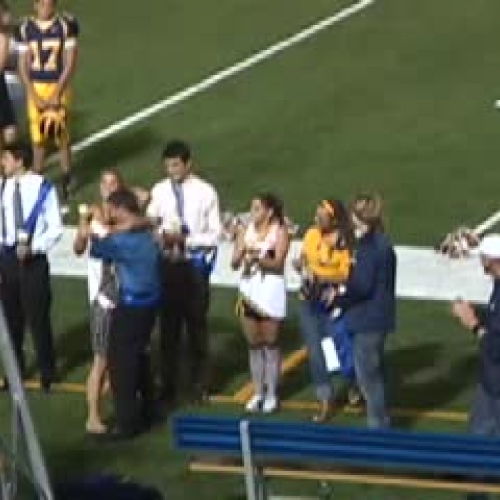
49, 0, 375, 163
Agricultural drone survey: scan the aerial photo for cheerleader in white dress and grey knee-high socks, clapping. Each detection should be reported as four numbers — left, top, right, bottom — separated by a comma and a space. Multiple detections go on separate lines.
231, 194, 290, 413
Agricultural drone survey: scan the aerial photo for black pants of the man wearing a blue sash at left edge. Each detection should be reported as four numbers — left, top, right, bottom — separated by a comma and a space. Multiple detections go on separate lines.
0, 251, 55, 387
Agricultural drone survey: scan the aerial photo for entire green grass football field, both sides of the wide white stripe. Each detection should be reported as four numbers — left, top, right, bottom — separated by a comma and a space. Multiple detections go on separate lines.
0, 0, 500, 500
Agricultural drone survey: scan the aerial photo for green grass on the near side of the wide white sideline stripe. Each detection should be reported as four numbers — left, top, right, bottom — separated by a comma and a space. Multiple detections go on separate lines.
0, 279, 476, 500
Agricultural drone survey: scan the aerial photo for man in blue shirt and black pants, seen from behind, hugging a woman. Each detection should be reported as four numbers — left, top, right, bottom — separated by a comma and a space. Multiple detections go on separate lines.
90, 190, 161, 439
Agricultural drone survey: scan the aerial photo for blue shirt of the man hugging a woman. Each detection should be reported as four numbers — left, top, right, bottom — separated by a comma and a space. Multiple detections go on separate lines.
90, 231, 161, 307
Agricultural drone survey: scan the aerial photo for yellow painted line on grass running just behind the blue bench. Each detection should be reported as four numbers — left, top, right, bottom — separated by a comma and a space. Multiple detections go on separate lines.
210, 396, 468, 423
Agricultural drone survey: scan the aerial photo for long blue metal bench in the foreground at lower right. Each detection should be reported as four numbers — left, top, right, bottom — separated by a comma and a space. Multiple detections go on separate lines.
173, 416, 500, 500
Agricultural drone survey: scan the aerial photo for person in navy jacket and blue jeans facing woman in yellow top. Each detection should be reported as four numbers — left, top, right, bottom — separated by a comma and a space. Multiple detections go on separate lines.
336, 195, 396, 428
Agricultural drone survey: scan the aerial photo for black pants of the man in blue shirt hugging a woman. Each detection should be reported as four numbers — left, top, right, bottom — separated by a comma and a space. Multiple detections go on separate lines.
108, 305, 157, 435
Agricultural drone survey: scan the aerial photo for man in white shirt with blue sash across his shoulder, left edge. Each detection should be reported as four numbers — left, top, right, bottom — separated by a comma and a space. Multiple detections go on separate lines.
0, 145, 63, 392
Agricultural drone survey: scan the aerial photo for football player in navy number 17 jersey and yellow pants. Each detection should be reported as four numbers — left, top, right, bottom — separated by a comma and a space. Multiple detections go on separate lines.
16, 0, 79, 201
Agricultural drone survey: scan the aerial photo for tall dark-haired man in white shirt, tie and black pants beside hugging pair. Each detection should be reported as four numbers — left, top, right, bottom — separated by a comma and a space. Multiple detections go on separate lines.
148, 140, 222, 403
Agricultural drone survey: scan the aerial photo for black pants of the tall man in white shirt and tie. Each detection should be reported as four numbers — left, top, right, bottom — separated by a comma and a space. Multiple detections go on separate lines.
160, 260, 210, 399
